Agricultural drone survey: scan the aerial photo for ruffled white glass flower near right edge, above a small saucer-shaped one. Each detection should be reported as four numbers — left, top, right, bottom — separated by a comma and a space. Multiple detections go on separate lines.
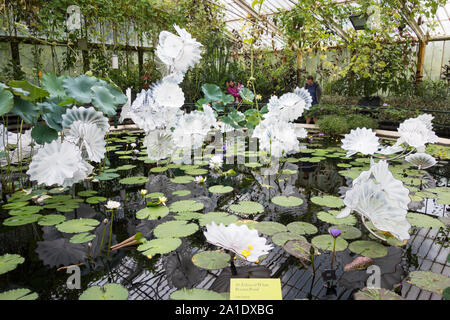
395, 113, 438, 152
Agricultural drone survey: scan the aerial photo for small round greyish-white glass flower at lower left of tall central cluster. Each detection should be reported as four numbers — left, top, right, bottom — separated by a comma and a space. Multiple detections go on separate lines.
144, 130, 175, 161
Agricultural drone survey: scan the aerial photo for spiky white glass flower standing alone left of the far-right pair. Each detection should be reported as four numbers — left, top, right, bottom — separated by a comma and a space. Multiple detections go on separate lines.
341, 128, 380, 157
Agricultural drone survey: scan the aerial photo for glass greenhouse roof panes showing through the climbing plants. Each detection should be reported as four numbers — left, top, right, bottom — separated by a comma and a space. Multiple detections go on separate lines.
220, 0, 450, 49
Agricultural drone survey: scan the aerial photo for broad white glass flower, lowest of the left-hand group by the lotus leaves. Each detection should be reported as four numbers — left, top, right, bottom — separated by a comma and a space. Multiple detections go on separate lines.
27, 140, 92, 186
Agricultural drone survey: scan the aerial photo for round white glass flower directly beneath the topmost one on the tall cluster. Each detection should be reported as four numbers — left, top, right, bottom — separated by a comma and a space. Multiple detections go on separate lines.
150, 79, 184, 109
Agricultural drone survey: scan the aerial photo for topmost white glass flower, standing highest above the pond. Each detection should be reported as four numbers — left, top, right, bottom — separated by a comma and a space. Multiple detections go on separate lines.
156, 25, 202, 73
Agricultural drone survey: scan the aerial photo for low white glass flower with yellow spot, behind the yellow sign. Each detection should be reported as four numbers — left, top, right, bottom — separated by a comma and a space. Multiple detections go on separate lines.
203, 221, 273, 262
